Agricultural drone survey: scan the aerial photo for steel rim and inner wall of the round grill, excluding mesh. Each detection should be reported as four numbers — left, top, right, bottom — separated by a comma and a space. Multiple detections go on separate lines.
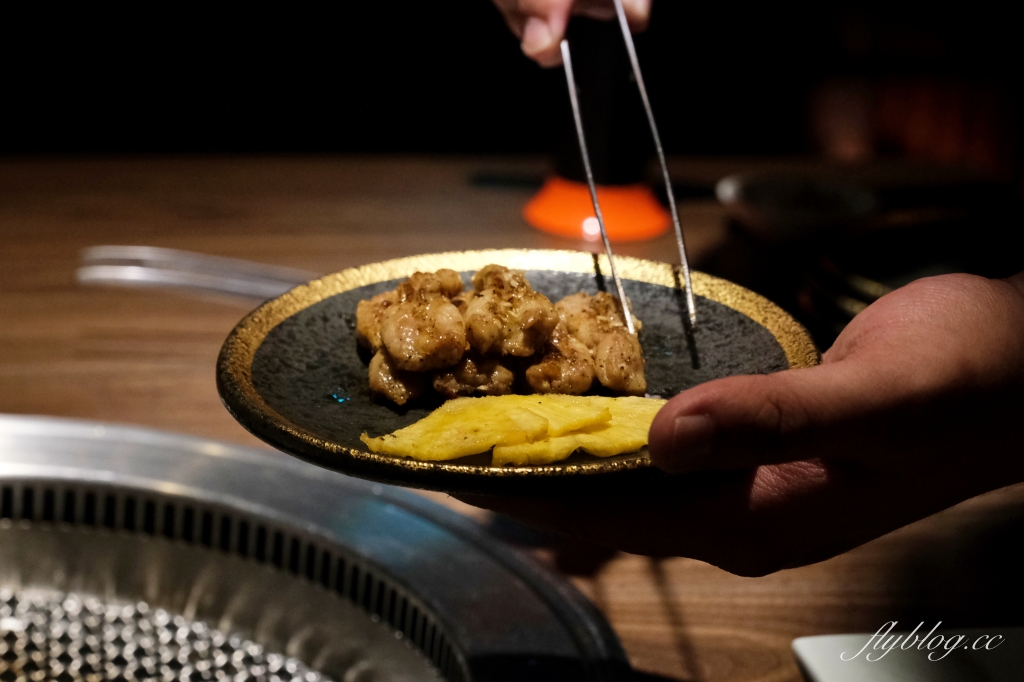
0, 416, 631, 681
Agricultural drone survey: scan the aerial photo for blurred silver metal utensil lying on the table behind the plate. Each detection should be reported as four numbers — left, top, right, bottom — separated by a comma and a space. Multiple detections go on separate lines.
75, 246, 317, 301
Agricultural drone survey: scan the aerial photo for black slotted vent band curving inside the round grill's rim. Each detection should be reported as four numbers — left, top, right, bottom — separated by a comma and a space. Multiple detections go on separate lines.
0, 480, 467, 682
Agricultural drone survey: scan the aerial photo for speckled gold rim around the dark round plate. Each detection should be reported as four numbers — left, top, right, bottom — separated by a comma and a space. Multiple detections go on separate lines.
217, 249, 820, 495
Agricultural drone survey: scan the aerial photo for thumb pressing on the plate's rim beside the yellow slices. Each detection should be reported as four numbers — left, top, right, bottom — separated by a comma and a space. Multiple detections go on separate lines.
649, 361, 880, 473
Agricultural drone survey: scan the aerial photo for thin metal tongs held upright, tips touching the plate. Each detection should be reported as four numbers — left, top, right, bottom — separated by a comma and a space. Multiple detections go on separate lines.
561, 0, 697, 334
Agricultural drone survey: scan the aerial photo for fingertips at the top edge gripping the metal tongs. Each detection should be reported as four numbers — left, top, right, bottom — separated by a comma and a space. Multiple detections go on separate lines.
495, 0, 650, 67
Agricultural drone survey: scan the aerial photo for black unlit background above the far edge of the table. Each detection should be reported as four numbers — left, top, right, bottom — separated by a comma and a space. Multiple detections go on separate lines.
0, 0, 1022, 165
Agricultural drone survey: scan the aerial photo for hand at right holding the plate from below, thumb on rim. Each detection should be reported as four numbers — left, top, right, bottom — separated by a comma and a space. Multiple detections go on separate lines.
466, 273, 1024, 576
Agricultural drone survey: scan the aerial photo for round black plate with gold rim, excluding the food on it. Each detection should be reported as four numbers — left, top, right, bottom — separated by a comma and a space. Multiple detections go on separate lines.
217, 250, 819, 495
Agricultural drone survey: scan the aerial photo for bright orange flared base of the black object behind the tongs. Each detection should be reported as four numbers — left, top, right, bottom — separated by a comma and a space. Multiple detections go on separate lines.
522, 177, 672, 242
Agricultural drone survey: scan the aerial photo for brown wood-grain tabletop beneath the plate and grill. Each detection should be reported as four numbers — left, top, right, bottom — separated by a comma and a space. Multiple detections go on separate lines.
0, 158, 1024, 682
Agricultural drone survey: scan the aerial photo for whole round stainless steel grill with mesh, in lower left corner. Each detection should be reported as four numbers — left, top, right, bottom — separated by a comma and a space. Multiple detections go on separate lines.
0, 416, 631, 682
